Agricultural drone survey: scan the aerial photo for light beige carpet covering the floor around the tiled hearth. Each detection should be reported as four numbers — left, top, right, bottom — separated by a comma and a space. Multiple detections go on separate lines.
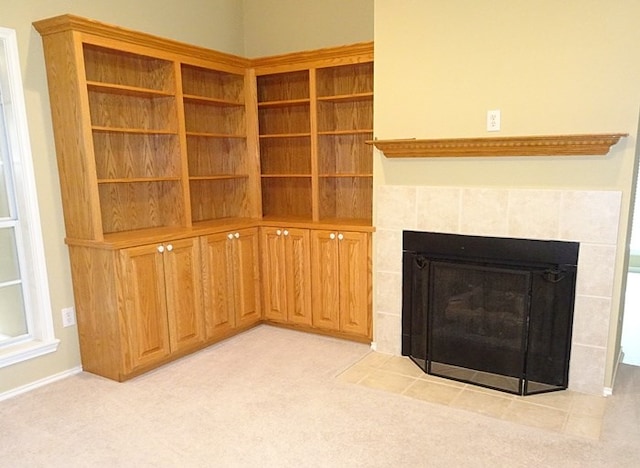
0, 326, 640, 467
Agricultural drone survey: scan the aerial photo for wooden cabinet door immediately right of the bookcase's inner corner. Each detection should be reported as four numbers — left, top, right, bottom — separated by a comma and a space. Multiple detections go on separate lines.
260, 227, 287, 322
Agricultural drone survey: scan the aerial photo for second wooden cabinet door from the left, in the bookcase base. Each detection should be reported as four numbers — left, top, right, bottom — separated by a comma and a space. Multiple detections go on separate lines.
163, 238, 204, 351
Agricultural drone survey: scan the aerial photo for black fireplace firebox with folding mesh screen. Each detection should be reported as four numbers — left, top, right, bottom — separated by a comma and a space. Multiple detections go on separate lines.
402, 231, 579, 395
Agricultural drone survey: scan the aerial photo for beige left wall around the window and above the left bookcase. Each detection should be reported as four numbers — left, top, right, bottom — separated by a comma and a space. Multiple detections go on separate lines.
0, 0, 243, 394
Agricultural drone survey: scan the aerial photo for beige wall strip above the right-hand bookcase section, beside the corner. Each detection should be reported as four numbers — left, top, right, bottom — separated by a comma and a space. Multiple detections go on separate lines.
244, 0, 376, 57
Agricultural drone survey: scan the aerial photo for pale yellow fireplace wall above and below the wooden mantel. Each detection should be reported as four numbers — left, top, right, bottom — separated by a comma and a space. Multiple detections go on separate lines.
374, 0, 640, 386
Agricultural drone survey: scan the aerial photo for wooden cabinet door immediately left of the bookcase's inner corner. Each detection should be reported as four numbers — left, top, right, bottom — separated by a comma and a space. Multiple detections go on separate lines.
231, 228, 262, 327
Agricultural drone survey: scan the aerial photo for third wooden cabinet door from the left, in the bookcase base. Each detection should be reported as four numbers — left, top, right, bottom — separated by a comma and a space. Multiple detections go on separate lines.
201, 233, 236, 339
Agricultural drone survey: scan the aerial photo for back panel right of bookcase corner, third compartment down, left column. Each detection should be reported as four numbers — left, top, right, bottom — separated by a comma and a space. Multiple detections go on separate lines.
260, 137, 311, 175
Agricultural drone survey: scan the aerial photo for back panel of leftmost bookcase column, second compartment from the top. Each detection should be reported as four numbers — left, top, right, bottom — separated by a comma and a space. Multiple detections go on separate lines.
89, 91, 178, 132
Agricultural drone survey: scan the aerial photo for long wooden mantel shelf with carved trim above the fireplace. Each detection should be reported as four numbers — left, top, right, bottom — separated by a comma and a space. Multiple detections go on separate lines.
367, 133, 628, 158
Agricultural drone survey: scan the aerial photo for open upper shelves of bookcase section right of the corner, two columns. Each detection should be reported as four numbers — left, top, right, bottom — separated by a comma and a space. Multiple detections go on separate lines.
256, 55, 373, 225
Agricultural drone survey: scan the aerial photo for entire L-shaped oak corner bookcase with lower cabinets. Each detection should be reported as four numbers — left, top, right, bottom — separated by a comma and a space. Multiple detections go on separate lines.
34, 15, 373, 380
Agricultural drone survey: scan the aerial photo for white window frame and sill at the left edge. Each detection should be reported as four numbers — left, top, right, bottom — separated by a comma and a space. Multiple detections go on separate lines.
0, 27, 60, 368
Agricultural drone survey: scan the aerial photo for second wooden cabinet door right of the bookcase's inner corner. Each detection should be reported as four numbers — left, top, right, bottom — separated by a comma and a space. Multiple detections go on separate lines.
283, 229, 312, 325
